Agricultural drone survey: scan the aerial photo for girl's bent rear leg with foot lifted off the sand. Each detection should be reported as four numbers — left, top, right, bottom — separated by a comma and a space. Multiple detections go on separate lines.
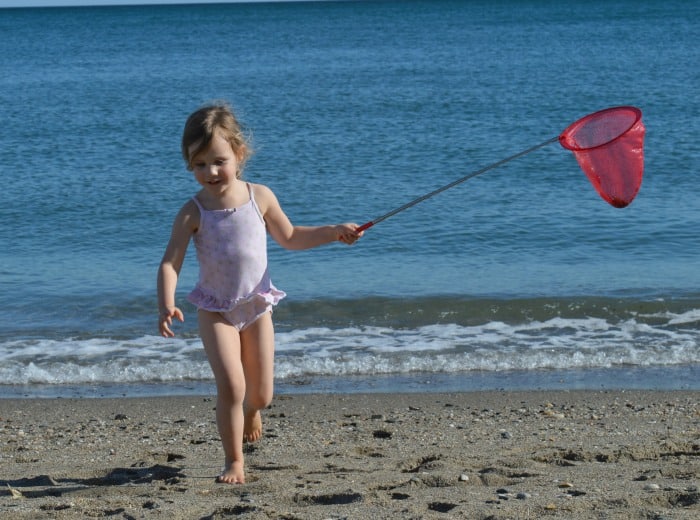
241, 312, 275, 442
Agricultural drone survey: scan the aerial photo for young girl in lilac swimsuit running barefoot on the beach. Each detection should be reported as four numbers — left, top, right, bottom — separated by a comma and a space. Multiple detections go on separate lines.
158, 104, 362, 484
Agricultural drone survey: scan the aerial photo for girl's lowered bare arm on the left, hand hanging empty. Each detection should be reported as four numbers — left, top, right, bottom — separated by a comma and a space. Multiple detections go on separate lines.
158, 200, 199, 338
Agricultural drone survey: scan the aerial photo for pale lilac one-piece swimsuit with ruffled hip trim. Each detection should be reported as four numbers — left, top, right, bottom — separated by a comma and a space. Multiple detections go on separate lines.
187, 185, 286, 330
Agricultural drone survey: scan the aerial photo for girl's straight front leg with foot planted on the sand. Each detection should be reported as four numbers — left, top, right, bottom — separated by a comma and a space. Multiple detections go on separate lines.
199, 310, 246, 484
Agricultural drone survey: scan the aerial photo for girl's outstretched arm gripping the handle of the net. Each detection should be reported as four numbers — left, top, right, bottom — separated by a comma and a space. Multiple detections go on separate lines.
254, 184, 362, 249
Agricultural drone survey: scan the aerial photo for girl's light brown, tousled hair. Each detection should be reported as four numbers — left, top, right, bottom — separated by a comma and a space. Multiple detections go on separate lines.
182, 103, 252, 178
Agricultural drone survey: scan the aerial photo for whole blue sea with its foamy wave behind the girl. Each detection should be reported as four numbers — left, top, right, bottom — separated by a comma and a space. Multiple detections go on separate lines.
0, 0, 700, 397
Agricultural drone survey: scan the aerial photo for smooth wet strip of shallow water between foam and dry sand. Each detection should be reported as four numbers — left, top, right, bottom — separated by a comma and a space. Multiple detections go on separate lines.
0, 364, 700, 400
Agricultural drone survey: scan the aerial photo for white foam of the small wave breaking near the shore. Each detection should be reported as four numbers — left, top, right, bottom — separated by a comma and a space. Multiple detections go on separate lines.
0, 316, 700, 384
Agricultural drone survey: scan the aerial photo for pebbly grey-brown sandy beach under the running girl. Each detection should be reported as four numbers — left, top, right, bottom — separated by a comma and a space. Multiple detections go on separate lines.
0, 391, 700, 520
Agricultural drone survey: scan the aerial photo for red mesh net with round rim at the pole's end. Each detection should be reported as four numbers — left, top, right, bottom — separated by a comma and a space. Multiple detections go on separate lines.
559, 106, 645, 208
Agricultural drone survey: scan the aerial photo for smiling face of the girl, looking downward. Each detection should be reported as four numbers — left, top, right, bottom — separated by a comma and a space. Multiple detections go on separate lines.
190, 132, 238, 194
